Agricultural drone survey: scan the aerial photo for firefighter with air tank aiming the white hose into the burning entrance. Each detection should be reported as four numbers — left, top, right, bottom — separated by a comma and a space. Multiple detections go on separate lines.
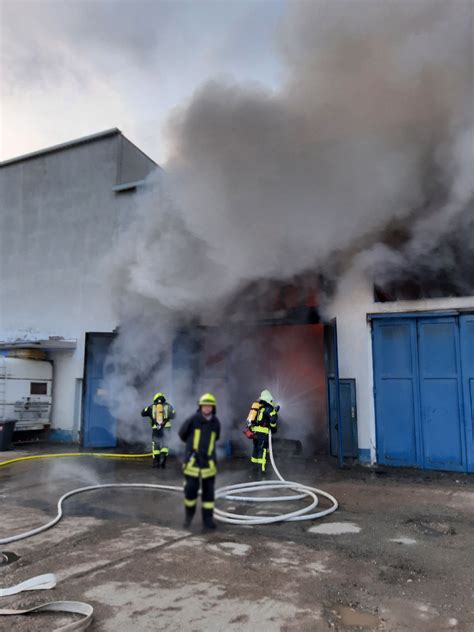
246, 389, 280, 475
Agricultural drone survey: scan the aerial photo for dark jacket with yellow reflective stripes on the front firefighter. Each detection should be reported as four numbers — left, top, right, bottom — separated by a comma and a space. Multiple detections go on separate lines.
178, 410, 221, 479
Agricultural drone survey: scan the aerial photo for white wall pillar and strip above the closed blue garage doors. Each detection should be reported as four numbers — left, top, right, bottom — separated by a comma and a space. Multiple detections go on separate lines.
327, 269, 474, 462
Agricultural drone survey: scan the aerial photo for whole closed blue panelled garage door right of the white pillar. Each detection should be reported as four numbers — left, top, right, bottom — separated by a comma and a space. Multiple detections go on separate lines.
373, 316, 474, 471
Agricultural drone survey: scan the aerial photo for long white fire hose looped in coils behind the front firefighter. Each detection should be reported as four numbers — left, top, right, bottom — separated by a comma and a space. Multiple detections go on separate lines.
0, 433, 338, 545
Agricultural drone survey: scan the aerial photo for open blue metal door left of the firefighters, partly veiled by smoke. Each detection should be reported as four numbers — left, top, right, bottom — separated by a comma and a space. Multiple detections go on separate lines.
82, 333, 117, 448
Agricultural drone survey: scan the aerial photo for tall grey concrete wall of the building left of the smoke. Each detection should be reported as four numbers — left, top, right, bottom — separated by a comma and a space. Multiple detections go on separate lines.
0, 133, 155, 438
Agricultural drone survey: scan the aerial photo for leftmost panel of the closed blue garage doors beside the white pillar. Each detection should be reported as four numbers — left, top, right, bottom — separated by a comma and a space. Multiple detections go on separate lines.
373, 319, 419, 466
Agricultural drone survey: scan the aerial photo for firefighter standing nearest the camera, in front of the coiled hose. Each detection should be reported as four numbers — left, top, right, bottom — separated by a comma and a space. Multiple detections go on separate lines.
179, 393, 221, 529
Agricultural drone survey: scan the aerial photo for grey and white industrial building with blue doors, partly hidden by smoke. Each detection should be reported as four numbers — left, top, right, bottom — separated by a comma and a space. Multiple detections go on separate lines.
0, 129, 474, 471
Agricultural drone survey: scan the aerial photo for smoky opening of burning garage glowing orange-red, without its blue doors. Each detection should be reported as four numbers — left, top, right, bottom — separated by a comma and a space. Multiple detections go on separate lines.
193, 324, 328, 456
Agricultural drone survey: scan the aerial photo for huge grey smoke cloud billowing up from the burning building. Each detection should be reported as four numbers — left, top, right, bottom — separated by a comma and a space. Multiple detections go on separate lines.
102, 0, 474, 454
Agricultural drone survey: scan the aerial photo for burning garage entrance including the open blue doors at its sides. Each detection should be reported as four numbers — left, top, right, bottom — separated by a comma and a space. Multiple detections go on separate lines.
173, 323, 350, 460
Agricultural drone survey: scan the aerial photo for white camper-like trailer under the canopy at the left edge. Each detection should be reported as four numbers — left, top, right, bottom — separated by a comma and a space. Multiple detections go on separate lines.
0, 356, 53, 431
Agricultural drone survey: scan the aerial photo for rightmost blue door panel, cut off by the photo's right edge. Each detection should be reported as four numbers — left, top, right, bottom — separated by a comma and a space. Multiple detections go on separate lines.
459, 314, 474, 472
